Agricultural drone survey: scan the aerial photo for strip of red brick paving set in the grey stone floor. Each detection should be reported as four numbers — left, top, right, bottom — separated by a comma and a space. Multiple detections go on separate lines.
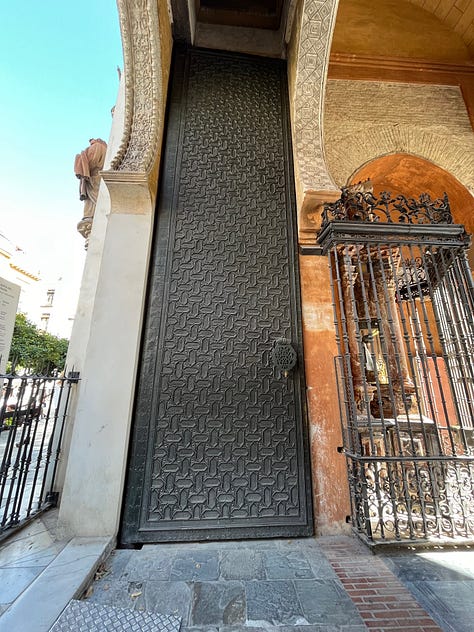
318, 538, 442, 632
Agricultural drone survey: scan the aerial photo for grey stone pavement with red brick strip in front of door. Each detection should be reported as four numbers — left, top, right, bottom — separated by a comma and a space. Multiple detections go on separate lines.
86, 537, 474, 632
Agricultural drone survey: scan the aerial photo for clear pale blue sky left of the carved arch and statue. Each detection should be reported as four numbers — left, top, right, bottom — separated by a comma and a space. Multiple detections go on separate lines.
0, 0, 123, 292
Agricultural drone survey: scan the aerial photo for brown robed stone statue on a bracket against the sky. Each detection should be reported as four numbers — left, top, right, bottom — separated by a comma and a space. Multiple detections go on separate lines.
74, 138, 107, 248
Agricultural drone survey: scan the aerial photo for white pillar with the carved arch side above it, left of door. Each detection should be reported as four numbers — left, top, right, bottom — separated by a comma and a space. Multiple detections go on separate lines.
58, 0, 172, 536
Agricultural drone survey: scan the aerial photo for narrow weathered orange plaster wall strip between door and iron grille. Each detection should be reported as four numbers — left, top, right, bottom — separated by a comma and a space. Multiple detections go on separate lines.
300, 255, 350, 535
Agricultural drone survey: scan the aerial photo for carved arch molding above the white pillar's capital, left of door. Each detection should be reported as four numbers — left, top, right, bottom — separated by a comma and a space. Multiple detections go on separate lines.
111, 0, 163, 174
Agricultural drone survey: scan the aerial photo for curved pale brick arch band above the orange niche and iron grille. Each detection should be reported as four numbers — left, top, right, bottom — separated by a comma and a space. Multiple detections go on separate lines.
328, 125, 474, 195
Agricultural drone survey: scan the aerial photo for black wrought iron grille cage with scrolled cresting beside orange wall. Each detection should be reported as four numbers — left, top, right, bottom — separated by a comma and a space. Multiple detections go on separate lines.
318, 189, 474, 543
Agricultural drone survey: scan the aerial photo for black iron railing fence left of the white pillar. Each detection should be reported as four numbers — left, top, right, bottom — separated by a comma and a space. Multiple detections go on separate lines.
0, 372, 78, 539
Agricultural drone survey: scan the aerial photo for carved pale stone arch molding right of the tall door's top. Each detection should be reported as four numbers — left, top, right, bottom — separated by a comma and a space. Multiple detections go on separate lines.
294, 0, 338, 190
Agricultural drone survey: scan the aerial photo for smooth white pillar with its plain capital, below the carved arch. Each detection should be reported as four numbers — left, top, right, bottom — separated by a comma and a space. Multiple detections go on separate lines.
59, 172, 154, 536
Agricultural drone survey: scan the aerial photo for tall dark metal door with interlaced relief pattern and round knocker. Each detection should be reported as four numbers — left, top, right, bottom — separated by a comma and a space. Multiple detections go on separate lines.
122, 50, 312, 543
